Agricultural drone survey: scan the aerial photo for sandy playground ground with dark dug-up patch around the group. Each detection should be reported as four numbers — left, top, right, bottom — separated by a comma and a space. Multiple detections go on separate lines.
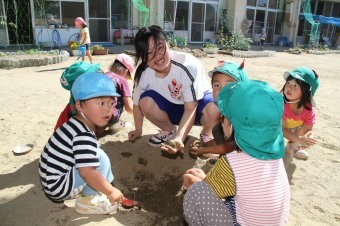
0, 52, 340, 226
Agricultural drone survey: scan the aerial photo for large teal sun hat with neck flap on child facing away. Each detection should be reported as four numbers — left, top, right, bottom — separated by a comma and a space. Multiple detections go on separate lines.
217, 80, 284, 160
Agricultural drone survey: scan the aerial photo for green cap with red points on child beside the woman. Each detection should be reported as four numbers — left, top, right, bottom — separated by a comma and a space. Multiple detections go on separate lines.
208, 61, 249, 82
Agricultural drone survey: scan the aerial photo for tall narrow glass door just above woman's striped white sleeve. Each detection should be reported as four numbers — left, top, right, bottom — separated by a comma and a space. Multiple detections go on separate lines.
190, 2, 205, 43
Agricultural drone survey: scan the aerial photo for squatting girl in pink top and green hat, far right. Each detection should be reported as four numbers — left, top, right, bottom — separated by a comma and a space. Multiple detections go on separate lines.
281, 67, 319, 159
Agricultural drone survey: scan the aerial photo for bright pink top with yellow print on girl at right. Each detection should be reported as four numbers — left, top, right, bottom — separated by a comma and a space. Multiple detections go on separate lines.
282, 103, 316, 129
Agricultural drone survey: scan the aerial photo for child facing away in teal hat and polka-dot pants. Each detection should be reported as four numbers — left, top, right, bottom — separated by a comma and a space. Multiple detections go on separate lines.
183, 81, 290, 226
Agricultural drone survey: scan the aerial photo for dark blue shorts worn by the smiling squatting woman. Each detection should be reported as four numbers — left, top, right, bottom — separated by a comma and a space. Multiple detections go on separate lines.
140, 90, 215, 126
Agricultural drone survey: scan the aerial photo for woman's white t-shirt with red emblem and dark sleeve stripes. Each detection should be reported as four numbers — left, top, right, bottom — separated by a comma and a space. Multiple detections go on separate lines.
133, 51, 211, 105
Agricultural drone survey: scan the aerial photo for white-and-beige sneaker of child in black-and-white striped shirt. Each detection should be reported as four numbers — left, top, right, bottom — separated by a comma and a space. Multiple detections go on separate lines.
75, 193, 118, 214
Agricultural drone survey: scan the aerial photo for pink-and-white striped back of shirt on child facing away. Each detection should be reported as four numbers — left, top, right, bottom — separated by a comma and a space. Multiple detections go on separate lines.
226, 151, 290, 226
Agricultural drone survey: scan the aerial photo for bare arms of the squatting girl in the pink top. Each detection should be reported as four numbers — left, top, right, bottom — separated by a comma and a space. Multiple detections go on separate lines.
282, 120, 317, 148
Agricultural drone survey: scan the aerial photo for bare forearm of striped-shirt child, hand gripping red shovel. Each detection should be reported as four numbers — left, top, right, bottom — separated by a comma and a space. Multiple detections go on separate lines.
78, 167, 124, 203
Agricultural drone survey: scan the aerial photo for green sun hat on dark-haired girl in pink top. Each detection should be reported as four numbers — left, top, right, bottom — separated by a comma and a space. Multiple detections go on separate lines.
283, 67, 319, 96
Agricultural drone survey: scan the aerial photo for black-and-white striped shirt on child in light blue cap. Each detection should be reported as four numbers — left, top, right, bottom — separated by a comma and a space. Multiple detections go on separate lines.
39, 118, 99, 200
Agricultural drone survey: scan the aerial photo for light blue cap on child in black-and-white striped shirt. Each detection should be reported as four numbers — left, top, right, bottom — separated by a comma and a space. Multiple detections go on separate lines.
71, 72, 120, 101
